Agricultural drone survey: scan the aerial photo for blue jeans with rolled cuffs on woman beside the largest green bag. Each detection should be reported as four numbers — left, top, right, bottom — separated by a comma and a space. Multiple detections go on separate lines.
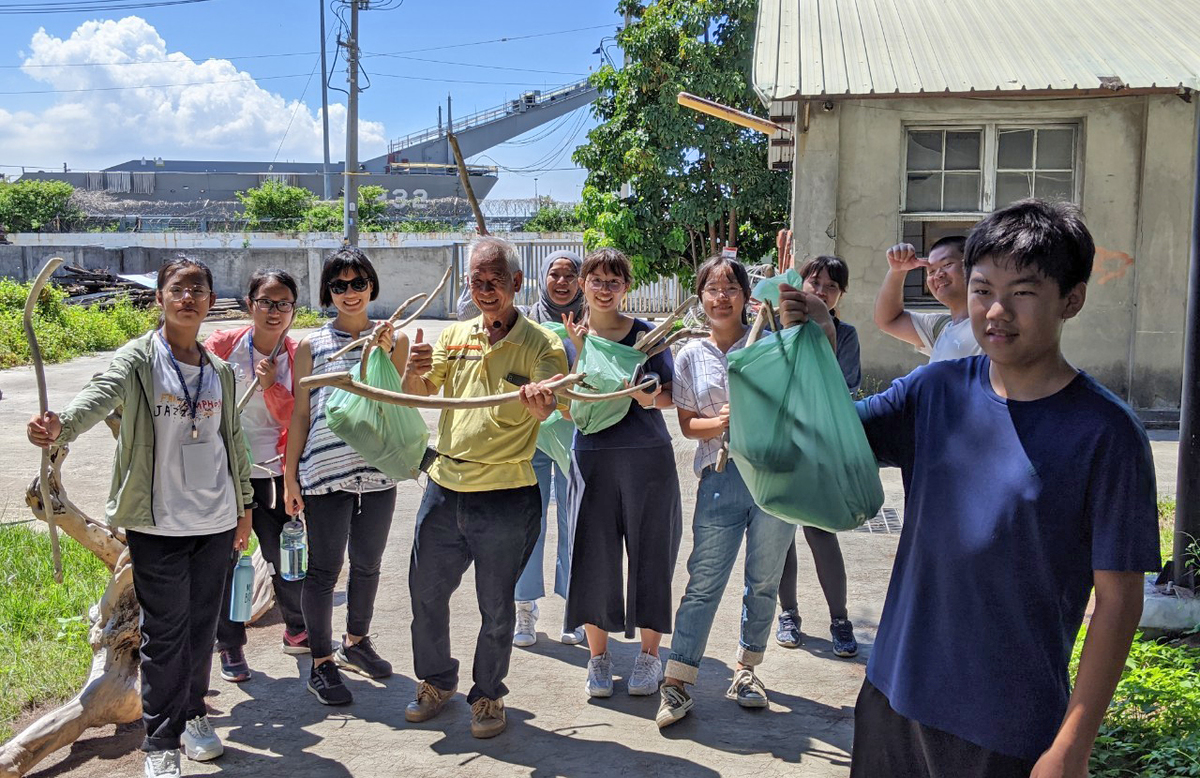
666, 461, 796, 683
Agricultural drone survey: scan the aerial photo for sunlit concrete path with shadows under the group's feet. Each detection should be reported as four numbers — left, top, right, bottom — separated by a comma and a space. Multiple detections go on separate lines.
0, 322, 1175, 778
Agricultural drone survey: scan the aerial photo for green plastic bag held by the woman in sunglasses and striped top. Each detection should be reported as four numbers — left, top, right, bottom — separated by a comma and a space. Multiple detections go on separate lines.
325, 348, 430, 480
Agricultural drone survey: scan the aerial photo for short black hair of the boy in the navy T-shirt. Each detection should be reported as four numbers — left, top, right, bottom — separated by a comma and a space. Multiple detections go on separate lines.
962, 198, 1096, 297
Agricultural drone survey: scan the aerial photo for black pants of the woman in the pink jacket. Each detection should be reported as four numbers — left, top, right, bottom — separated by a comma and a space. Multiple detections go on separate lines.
217, 475, 304, 651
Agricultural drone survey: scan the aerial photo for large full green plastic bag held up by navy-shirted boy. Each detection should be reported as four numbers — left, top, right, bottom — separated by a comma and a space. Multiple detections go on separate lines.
728, 322, 883, 532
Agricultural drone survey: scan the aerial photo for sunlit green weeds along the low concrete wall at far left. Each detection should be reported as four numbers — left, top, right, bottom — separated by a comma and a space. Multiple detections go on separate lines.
0, 279, 158, 369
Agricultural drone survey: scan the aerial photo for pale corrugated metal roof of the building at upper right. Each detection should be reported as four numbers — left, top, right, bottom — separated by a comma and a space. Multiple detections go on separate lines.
754, 0, 1200, 101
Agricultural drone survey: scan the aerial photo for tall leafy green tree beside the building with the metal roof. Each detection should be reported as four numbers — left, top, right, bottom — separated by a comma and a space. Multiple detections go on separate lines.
574, 0, 788, 280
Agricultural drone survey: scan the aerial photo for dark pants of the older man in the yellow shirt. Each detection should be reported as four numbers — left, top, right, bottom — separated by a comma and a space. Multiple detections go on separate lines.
408, 480, 541, 702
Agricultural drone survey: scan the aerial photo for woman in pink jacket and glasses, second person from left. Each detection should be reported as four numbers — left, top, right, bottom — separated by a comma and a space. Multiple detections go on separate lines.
204, 270, 308, 683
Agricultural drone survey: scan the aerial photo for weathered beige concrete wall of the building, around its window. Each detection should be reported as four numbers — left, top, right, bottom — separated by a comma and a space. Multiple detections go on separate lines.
793, 96, 1198, 408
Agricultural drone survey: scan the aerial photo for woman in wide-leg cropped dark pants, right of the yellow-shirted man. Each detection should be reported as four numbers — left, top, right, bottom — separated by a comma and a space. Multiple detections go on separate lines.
564, 249, 683, 698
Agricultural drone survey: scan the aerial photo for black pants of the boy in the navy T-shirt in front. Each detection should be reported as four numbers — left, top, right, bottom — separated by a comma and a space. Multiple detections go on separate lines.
850, 681, 1034, 778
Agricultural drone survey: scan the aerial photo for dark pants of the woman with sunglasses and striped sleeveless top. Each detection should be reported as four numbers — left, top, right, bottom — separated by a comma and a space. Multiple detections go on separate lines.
301, 486, 396, 658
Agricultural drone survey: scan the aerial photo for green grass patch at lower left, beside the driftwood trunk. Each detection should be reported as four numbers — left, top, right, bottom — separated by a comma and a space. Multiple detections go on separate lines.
0, 526, 109, 742
